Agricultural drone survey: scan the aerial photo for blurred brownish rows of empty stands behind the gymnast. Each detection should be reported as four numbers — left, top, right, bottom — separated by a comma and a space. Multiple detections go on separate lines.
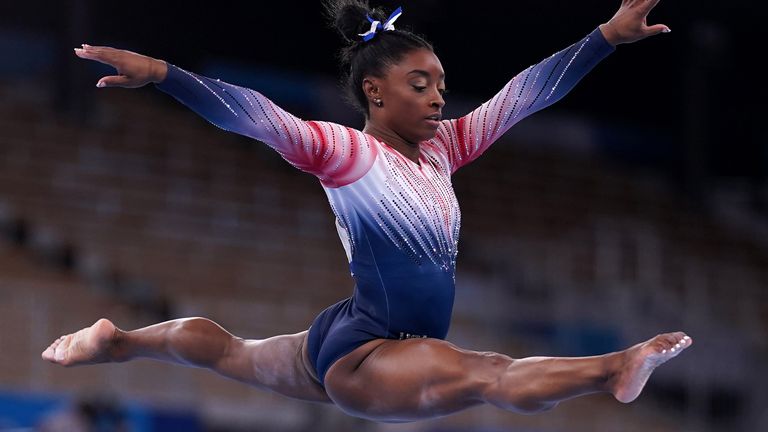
0, 70, 768, 432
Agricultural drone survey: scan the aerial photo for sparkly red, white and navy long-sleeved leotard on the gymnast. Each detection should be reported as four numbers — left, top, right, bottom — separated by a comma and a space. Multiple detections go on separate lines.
158, 29, 613, 383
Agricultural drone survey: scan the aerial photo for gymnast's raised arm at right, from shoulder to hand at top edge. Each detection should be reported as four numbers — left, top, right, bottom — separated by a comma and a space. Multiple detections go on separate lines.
437, 0, 669, 172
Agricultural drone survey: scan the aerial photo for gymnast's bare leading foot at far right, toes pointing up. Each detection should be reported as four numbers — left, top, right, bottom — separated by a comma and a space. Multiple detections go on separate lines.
611, 332, 693, 403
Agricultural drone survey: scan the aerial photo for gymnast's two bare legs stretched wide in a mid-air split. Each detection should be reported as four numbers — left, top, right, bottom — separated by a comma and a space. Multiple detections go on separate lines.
43, 318, 692, 422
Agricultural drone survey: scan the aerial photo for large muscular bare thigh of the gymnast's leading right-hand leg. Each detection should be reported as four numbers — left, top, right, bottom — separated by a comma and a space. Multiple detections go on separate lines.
325, 339, 512, 422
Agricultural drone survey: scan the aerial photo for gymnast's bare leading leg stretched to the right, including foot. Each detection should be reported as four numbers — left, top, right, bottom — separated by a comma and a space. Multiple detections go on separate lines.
325, 333, 691, 422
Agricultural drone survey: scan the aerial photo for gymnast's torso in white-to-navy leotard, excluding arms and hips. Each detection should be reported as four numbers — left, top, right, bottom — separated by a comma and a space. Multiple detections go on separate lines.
325, 134, 461, 338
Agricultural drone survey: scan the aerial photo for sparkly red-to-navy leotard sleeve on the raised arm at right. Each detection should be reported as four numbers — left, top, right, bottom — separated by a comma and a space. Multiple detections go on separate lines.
434, 28, 615, 173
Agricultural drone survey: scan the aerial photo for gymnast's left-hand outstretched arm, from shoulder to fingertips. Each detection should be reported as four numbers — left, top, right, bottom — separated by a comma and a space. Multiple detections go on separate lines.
75, 45, 372, 186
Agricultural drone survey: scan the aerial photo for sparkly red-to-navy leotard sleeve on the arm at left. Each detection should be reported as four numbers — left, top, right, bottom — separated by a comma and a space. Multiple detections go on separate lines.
157, 64, 375, 187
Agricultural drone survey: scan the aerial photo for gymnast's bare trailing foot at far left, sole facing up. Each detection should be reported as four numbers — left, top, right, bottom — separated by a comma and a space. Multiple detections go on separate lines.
42, 318, 117, 366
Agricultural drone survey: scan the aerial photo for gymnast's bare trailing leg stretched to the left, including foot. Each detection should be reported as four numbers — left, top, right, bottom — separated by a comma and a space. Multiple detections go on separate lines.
42, 318, 330, 402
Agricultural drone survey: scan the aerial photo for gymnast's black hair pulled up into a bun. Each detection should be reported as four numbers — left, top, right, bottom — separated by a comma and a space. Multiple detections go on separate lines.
325, 0, 433, 118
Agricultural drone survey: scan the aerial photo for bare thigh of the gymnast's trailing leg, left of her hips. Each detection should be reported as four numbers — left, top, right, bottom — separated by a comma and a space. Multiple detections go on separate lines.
217, 331, 331, 402
